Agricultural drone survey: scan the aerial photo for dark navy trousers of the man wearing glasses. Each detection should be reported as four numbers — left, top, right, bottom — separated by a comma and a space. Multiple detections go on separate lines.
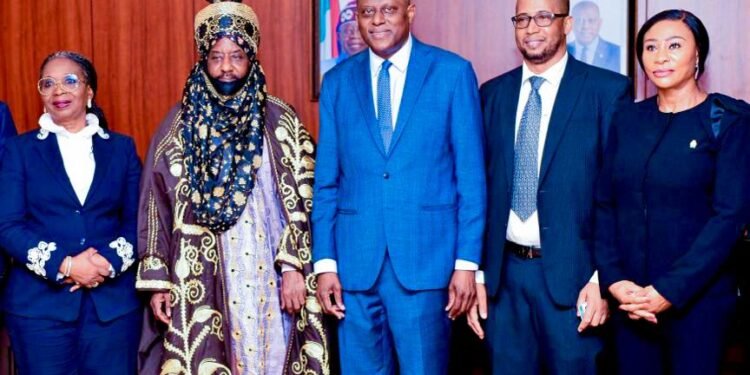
486, 254, 603, 375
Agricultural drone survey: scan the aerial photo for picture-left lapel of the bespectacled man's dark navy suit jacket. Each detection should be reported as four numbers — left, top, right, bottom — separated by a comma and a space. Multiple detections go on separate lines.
506, 69, 522, 186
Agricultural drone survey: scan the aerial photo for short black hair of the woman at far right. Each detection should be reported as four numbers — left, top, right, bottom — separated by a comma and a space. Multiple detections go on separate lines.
635, 9, 710, 78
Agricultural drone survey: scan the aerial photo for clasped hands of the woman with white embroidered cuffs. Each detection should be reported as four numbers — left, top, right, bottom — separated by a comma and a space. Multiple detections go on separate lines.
59, 247, 111, 293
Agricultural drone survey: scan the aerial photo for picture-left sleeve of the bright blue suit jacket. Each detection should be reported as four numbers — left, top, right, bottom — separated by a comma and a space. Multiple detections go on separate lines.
312, 74, 340, 262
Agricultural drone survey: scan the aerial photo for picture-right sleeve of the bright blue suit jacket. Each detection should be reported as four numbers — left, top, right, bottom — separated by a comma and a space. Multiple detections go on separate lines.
449, 62, 487, 264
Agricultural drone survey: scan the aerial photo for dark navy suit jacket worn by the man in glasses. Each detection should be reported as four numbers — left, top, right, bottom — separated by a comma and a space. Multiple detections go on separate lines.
480, 56, 631, 306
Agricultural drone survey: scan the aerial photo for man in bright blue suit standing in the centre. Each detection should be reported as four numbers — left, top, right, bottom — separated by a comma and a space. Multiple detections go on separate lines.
312, 0, 485, 375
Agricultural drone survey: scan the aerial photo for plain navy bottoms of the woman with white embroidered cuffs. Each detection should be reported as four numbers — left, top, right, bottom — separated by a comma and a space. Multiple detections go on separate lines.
5, 291, 142, 375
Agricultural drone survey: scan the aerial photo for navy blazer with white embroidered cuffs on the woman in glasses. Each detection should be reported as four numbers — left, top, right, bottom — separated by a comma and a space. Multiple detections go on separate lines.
0, 131, 141, 321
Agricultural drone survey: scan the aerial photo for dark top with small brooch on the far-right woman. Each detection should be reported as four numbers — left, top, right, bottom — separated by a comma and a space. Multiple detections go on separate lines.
596, 94, 750, 308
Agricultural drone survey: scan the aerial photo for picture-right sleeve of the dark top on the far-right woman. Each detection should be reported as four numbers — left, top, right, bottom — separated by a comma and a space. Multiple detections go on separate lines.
654, 114, 750, 308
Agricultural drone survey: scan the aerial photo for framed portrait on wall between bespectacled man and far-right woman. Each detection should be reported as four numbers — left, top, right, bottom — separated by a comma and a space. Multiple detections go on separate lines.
568, 0, 634, 77
